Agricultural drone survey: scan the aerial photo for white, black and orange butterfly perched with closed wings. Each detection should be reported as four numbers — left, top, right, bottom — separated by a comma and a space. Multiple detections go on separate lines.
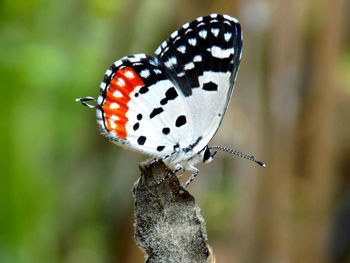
76, 14, 265, 187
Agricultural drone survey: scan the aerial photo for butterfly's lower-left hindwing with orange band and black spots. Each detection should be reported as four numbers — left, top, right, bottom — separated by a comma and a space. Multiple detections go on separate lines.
97, 54, 191, 156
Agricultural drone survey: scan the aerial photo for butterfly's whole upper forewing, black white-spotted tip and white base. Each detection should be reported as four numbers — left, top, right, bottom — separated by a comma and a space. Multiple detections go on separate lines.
155, 14, 242, 154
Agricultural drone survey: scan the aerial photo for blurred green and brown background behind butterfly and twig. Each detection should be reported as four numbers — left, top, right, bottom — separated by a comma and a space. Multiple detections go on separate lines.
0, 0, 350, 263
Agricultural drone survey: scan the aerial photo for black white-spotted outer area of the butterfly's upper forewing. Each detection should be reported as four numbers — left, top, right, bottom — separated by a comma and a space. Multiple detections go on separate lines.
155, 14, 242, 96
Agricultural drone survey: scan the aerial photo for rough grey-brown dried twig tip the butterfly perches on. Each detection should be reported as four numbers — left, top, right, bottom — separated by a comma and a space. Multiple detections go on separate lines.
133, 161, 215, 263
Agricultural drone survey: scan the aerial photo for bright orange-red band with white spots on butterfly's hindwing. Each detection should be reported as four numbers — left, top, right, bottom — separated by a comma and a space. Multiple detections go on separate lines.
102, 67, 145, 139
